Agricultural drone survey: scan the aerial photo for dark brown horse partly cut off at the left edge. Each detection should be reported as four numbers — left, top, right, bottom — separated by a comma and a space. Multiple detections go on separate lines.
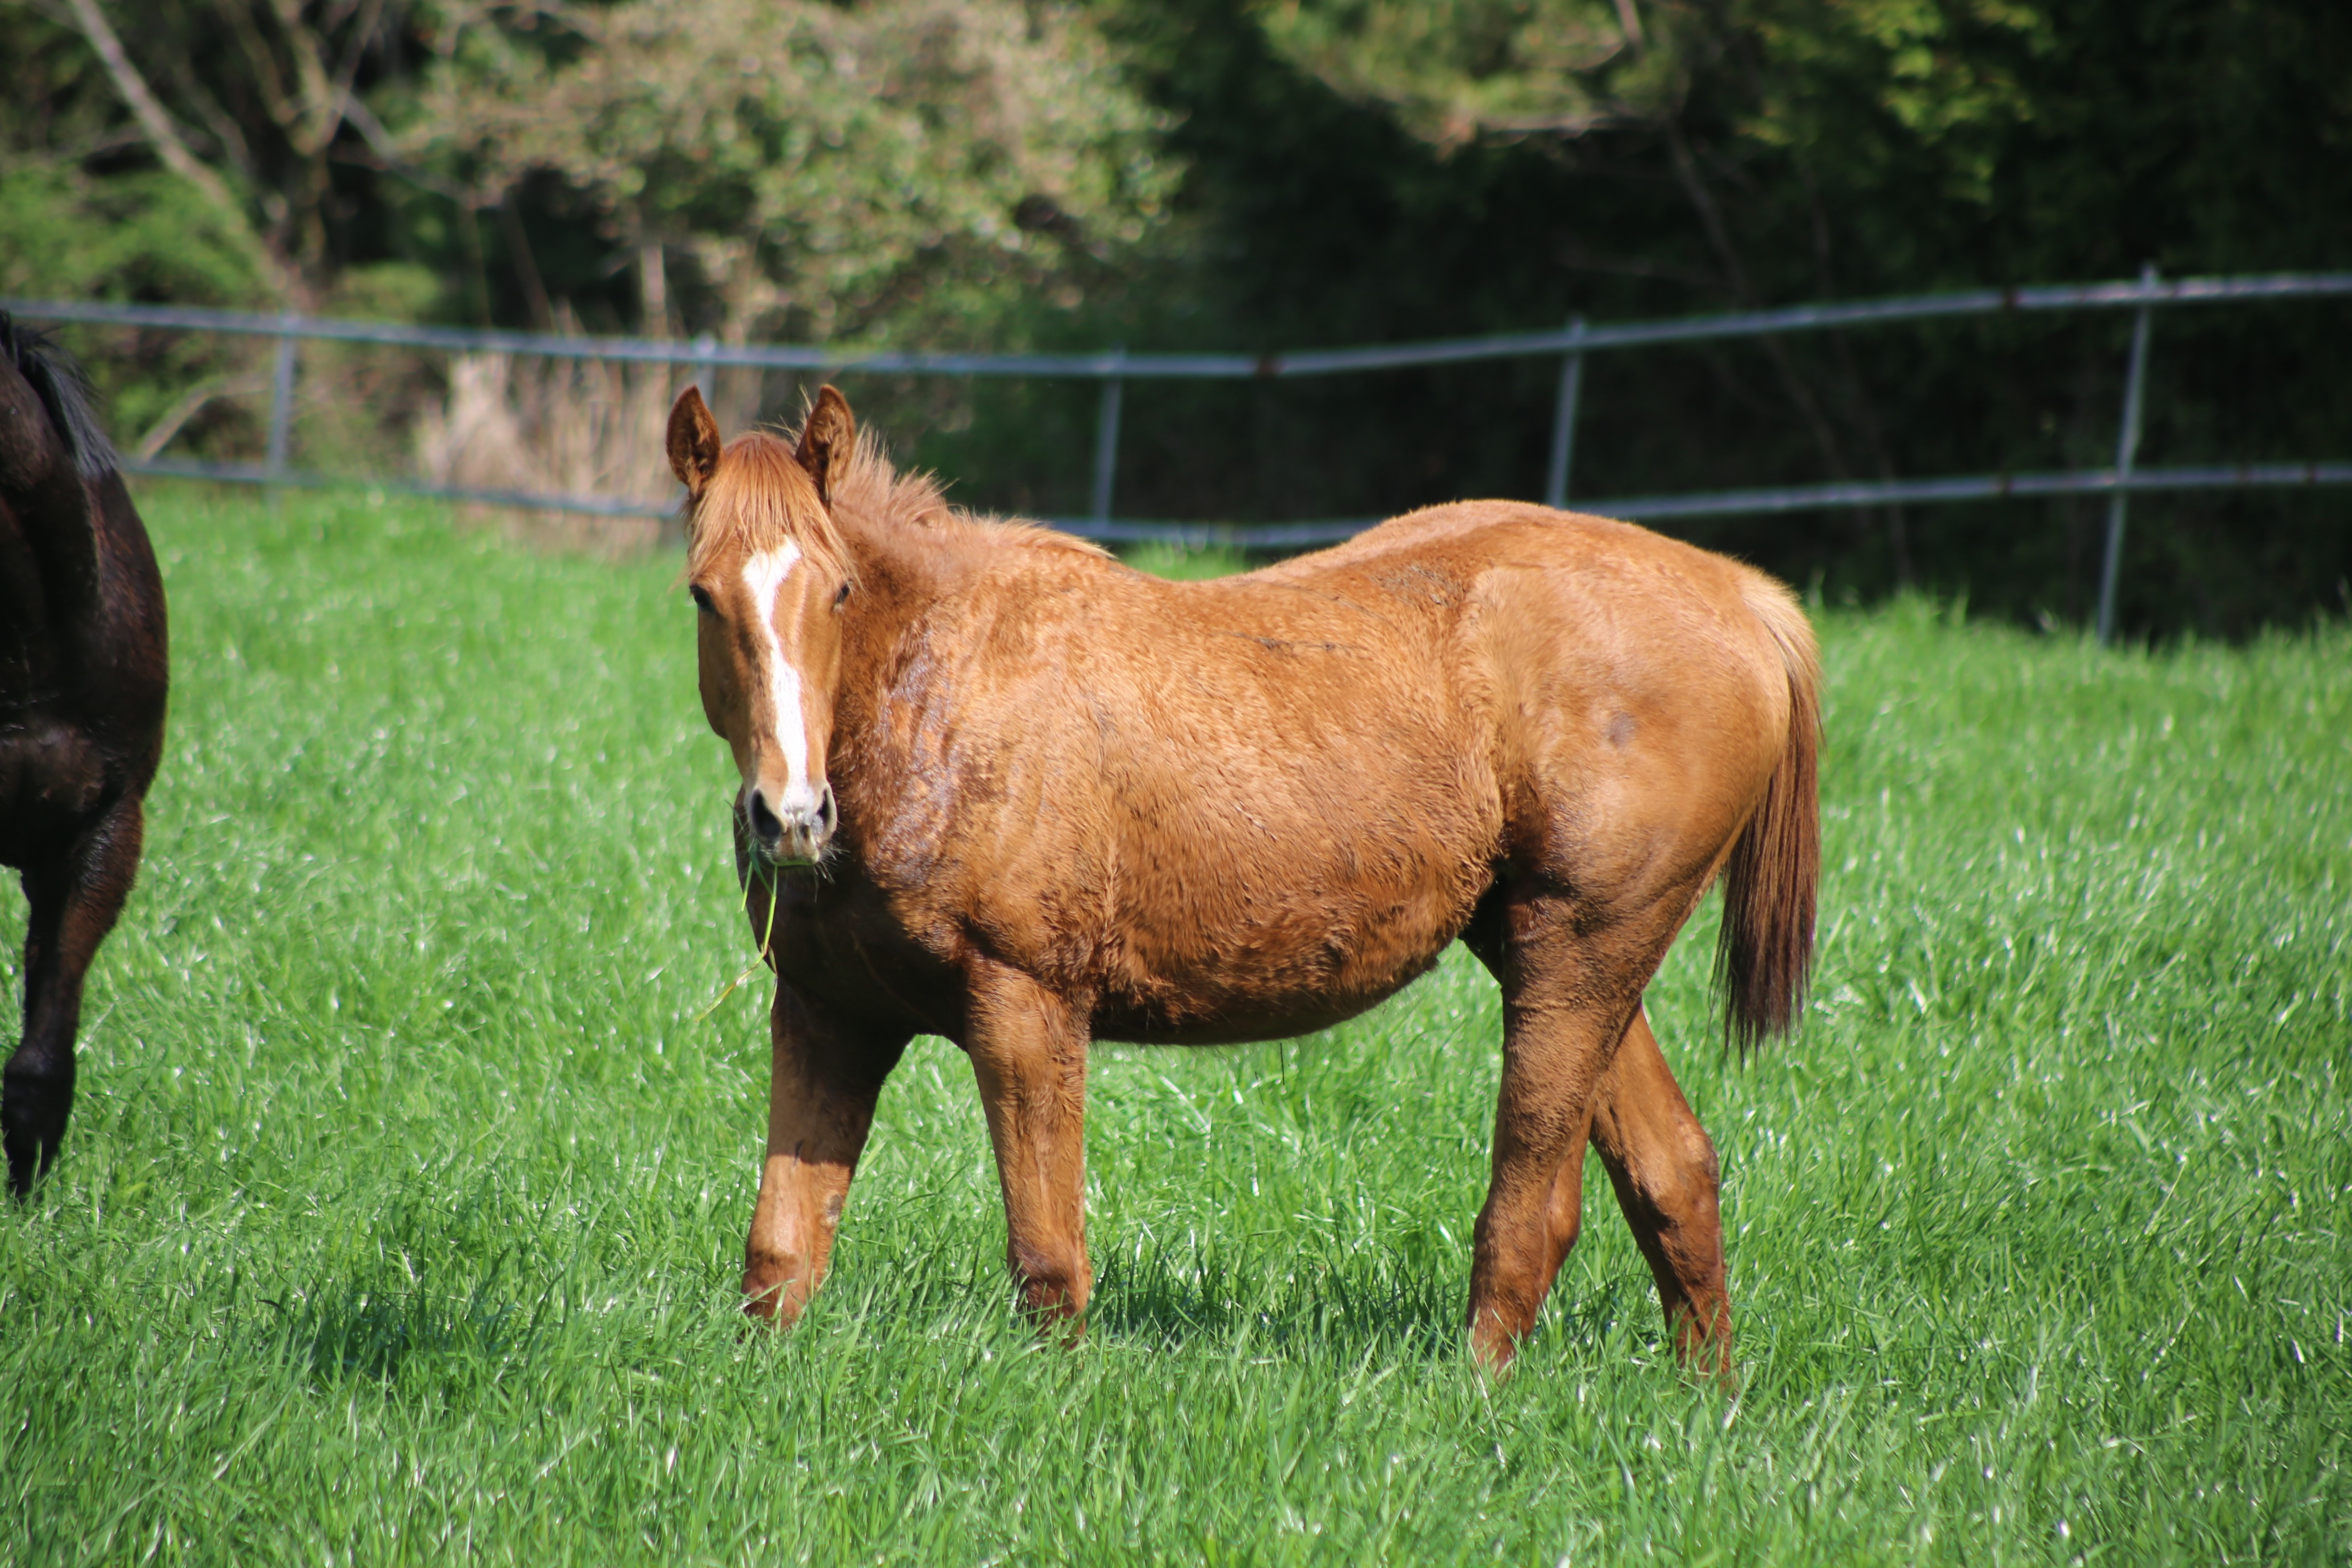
0, 315, 167, 1197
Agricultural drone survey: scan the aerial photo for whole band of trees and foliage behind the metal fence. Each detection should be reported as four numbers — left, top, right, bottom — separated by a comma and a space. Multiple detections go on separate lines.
0, 0, 2352, 637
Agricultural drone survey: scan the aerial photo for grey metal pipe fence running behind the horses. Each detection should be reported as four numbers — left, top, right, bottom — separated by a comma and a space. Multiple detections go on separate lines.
0, 265, 2352, 642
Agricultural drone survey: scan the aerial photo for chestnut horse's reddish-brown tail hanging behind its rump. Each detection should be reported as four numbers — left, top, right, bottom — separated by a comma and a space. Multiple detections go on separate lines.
1715, 576, 1821, 1053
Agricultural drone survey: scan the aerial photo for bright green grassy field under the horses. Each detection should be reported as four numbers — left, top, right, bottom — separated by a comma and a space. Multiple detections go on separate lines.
0, 491, 2352, 1563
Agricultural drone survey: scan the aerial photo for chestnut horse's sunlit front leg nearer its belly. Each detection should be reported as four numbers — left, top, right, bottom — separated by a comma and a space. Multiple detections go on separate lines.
964, 964, 1094, 1319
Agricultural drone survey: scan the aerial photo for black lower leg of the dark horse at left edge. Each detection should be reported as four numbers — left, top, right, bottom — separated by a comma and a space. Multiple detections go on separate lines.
0, 799, 146, 1199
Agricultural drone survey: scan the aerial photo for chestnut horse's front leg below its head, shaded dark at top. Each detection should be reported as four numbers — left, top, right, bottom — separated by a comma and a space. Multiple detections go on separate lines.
743, 980, 908, 1323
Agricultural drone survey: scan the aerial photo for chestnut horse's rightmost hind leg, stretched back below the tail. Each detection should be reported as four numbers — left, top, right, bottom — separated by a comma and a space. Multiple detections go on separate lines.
1592, 1013, 1731, 1378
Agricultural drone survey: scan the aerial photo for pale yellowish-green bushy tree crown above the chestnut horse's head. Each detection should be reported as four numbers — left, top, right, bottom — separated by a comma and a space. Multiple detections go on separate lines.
412, 0, 1166, 338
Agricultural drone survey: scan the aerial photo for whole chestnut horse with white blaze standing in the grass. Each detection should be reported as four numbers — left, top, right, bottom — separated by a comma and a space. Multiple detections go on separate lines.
668, 388, 1821, 1373
